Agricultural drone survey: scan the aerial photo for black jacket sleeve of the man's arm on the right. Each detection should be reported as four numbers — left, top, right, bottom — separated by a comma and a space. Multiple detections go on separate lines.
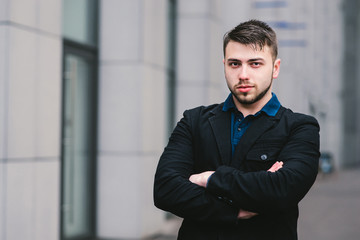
207, 115, 320, 213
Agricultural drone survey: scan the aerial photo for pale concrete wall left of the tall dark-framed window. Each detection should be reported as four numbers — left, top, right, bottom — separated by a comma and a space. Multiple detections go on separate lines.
0, 0, 62, 240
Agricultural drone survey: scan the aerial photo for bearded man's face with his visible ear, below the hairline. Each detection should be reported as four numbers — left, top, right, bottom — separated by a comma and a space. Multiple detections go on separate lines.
224, 41, 280, 109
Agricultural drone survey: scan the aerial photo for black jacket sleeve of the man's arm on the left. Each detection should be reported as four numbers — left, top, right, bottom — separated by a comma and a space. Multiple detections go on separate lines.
154, 111, 238, 224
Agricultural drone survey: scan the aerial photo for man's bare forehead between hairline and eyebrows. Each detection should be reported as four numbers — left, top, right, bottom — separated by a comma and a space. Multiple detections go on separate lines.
225, 41, 272, 60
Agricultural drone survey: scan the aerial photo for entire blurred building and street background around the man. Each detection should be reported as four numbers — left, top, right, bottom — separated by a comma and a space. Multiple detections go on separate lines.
0, 0, 360, 240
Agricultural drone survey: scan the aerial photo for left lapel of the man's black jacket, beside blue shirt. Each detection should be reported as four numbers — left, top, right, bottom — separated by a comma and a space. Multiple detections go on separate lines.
209, 104, 231, 165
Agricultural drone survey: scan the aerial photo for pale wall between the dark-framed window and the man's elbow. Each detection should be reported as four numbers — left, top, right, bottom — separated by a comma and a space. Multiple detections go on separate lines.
98, 0, 167, 239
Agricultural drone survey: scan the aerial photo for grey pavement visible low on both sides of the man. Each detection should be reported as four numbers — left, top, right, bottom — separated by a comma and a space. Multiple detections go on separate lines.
151, 168, 360, 240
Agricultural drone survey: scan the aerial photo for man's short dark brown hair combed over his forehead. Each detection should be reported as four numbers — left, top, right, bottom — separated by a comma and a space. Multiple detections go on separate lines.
223, 19, 278, 60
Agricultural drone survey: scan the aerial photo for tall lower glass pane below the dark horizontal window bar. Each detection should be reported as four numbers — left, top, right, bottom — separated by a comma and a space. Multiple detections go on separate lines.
62, 48, 97, 239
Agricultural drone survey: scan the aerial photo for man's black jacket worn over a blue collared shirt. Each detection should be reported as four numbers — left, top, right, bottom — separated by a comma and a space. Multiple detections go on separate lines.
154, 104, 320, 240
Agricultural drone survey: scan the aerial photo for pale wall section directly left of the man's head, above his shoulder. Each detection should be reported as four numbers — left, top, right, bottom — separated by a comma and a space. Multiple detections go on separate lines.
176, 0, 228, 120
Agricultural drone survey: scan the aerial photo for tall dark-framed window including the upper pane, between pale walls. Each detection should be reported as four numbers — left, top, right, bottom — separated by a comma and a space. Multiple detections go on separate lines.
61, 0, 98, 240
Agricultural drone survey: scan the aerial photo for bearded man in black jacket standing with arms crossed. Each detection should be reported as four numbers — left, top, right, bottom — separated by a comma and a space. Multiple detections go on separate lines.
154, 20, 320, 240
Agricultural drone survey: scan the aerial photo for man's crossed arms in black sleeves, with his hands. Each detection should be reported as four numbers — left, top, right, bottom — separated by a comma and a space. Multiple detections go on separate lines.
154, 109, 319, 224
